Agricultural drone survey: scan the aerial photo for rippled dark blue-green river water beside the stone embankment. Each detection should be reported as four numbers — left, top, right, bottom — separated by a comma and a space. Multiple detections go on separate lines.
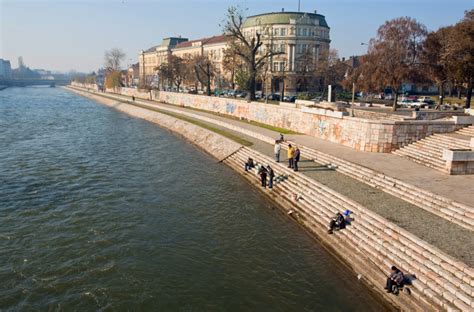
0, 88, 386, 311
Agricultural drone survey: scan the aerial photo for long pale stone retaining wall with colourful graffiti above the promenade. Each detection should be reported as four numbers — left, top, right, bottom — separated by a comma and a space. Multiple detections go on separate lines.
70, 82, 457, 153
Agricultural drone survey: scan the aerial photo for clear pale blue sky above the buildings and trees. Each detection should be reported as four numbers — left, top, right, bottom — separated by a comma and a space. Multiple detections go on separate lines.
0, 0, 474, 72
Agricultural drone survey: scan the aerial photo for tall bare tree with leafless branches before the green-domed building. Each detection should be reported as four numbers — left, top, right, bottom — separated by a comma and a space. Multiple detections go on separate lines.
223, 7, 283, 100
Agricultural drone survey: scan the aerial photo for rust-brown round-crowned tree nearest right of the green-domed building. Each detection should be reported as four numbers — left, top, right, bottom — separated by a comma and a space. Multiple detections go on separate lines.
363, 17, 427, 111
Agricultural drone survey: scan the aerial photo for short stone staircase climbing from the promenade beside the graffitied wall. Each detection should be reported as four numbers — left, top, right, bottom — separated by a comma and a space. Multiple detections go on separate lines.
392, 132, 470, 173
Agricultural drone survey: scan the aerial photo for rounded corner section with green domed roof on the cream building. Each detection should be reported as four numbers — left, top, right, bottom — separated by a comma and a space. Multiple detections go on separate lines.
242, 12, 331, 95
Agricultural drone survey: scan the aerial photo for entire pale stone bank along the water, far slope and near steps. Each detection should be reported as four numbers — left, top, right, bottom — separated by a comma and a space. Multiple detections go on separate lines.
65, 86, 472, 310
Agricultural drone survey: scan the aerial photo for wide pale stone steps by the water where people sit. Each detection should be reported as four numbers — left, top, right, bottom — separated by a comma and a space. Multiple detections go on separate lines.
224, 148, 474, 311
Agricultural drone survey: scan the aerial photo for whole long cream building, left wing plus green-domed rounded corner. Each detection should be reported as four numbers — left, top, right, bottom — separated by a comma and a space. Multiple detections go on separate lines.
139, 12, 331, 95
